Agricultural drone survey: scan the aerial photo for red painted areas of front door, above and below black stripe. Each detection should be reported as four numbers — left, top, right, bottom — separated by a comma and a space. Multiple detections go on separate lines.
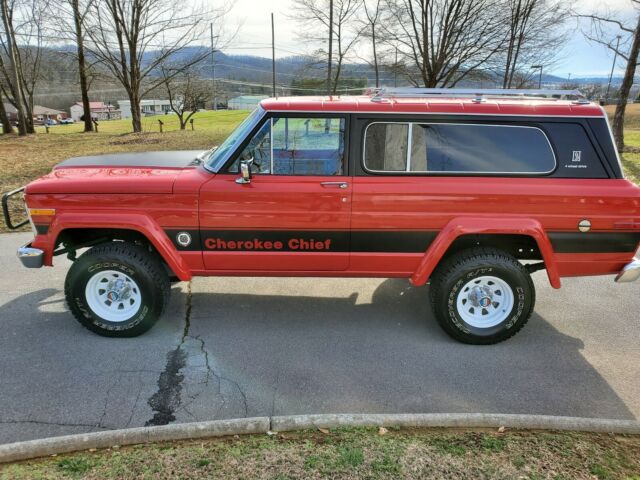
200, 174, 351, 271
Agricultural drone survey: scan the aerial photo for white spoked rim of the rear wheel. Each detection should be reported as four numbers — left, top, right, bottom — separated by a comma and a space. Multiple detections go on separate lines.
456, 276, 514, 328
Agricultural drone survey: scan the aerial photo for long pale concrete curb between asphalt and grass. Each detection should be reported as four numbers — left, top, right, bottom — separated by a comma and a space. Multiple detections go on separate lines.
0, 413, 640, 463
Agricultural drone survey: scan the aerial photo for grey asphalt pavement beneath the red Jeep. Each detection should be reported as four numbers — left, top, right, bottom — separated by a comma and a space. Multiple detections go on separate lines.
0, 234, 640, 443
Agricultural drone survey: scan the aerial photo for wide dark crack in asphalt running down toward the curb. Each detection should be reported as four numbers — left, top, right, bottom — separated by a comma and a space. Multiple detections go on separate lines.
145, 282, 192, 426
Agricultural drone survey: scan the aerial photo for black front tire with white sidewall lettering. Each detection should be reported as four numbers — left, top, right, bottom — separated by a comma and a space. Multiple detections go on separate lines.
64, 242, 171, 337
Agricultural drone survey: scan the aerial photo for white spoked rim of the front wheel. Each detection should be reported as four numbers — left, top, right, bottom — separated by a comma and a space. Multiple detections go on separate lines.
85, 270, 142, 322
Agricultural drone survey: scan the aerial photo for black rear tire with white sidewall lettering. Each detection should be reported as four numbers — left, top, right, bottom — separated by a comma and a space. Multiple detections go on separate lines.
430, 248, 536, 345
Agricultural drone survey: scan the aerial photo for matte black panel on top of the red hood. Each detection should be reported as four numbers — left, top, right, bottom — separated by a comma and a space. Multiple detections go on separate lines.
54, 150, 203, 170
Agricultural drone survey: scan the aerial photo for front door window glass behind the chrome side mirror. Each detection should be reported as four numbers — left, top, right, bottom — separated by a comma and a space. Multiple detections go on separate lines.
229, 117, 345, 176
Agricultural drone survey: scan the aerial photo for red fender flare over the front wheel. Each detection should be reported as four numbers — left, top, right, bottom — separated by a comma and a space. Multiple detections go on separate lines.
33, 212, 192, 282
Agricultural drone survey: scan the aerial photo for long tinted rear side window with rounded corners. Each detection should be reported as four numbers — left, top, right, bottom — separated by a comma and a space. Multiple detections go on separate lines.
364, 122, 556, 174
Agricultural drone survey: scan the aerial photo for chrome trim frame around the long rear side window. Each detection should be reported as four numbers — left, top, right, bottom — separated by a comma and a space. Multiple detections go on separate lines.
361, 121, 558, 176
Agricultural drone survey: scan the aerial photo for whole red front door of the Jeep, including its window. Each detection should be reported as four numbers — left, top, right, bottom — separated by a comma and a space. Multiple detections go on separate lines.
200, 114, 352, 273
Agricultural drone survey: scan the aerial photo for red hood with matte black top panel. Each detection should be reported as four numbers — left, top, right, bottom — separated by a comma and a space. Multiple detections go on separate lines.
26, 150, 202, 194
